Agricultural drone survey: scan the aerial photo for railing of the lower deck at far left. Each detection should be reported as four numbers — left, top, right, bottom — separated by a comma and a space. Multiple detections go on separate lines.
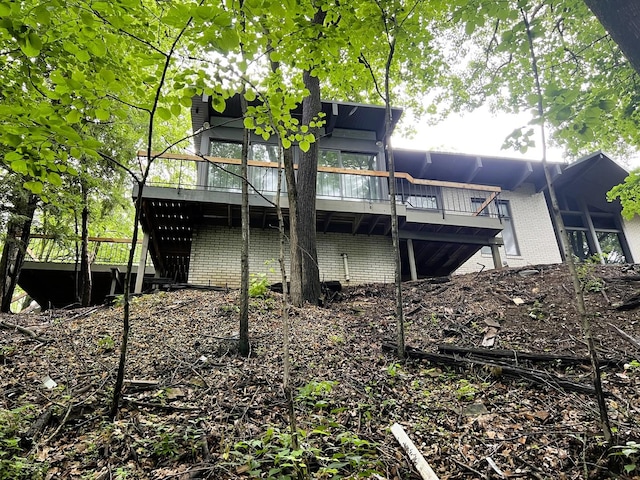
26, 234, 152, 266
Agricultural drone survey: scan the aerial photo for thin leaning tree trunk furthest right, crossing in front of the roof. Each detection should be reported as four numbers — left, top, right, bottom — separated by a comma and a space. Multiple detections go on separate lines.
520, 9, 613, 443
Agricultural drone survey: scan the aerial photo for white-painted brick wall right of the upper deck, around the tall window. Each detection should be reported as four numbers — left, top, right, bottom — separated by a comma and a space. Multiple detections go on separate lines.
455, 184, 562, 273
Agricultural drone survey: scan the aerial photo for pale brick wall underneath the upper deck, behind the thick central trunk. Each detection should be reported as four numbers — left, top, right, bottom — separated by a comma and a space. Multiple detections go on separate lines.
189, 226, 393, 288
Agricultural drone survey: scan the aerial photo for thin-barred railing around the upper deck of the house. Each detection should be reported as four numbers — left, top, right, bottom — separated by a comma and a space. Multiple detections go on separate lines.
142, 154, 500, 217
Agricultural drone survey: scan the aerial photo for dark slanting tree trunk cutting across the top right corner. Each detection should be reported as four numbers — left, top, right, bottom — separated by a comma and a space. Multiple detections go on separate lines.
584, 0, 640, 74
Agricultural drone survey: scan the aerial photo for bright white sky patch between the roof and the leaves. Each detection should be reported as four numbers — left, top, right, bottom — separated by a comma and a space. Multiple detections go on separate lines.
392, 107, 640, 168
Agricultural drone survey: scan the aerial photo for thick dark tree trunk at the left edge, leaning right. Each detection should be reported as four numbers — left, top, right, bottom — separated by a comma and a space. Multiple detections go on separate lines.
0, 186, 36, 313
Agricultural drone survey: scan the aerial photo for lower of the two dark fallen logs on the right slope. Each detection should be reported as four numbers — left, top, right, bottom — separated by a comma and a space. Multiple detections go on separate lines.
382, 343, 611, 396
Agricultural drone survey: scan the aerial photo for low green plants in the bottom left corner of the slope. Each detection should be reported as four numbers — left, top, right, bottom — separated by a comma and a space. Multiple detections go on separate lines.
0, 405, 47, 480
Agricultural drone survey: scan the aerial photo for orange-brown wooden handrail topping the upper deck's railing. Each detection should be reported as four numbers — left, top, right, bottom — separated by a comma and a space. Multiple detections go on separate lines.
138, 152, 502, 193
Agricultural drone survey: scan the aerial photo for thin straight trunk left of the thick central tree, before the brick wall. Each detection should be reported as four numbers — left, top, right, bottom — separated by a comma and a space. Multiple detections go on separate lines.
239, 95, 250, 357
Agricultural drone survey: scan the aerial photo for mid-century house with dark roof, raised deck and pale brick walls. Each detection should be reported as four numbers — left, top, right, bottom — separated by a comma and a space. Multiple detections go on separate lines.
134, 97, 640, 289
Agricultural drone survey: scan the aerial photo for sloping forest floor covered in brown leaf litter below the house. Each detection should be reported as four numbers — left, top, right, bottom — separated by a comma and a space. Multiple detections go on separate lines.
0, 265, 640, 480
